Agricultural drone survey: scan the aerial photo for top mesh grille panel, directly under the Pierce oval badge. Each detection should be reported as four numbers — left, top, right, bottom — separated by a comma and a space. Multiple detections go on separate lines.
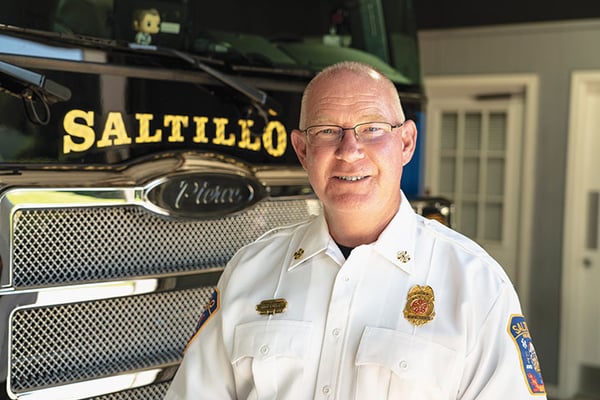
12, 200, 309, 287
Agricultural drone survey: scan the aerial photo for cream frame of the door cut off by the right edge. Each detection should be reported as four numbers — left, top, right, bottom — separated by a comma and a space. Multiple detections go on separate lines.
558, 70, 600, 398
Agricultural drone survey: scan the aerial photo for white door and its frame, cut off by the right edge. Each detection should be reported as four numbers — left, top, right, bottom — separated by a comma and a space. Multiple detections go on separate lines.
559, 71, 600, 396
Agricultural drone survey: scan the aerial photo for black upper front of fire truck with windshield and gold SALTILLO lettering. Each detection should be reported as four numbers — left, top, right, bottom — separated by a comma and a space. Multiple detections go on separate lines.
0, 0, 422, 165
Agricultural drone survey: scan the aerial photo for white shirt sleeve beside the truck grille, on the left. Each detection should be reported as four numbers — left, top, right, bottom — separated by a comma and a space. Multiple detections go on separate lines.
165, 290, 236, 400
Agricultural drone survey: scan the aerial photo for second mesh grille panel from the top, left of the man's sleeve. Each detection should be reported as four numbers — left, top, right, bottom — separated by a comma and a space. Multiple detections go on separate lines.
10, 287, 213, 398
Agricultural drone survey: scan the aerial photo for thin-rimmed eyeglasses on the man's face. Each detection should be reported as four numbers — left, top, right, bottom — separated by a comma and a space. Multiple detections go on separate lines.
302, 122, 404, 147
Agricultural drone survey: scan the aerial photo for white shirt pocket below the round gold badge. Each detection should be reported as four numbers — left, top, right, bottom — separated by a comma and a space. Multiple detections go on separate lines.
356, 327, 460, 400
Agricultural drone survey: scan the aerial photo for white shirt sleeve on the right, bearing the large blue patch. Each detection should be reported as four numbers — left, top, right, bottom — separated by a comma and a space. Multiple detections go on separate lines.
458, 283, 546, 400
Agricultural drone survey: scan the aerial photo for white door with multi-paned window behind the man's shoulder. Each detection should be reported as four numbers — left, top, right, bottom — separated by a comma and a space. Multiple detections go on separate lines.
425, 78, 535, 296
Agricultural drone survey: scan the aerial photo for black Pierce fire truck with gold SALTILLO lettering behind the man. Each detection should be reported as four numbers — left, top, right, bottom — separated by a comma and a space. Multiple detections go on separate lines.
0, 0, 451, 400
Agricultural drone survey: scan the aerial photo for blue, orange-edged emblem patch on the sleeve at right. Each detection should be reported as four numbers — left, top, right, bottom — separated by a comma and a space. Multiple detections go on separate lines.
508, 314, 546, 394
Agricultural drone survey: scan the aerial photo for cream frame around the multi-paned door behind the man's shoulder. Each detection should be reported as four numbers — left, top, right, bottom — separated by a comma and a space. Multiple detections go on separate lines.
424, 74, 539, 315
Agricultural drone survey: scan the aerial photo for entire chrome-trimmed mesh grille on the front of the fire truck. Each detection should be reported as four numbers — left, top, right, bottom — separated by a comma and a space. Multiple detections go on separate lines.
0, 192, 318, 400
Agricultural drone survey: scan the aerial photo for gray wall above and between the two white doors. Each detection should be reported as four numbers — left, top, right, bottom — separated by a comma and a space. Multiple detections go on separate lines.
419, 19, 600, 385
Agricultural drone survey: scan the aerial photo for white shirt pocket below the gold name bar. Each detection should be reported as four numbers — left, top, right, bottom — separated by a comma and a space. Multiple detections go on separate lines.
231, 320, 312, 400
